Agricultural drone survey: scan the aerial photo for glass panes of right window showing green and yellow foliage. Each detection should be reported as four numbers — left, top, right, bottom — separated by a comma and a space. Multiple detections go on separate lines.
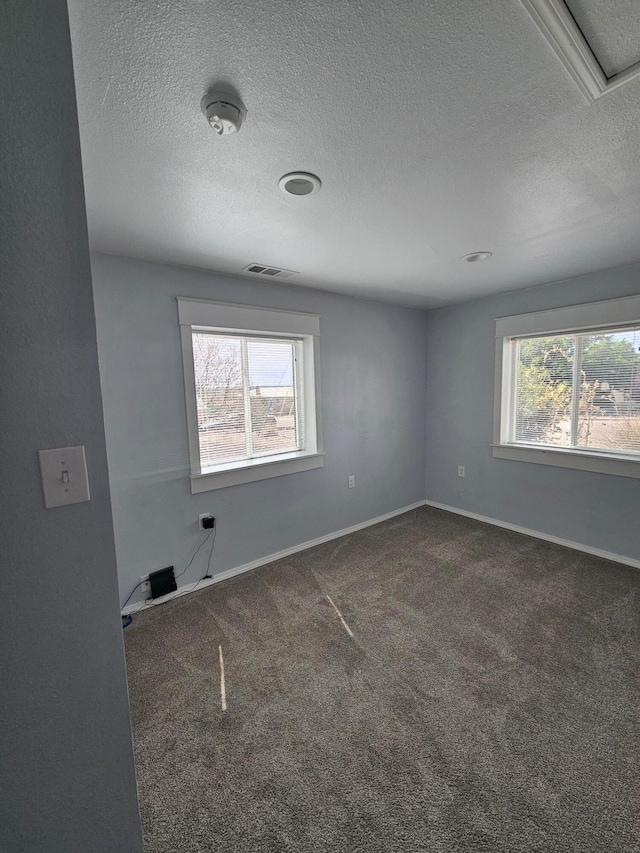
512, 327, 640, 455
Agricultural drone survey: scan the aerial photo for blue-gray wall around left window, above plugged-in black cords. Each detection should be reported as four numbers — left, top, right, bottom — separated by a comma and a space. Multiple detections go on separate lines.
92, 255, 426, 602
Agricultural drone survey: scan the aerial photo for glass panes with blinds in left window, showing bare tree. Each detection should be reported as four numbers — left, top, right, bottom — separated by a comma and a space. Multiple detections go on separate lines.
192, 332, 302, 470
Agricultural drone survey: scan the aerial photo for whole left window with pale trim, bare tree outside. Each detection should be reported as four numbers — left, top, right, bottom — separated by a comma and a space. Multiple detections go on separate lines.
178, 299, 323, 493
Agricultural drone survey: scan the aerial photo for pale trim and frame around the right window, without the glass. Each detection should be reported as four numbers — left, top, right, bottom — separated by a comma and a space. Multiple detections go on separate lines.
492, 296, 640, 478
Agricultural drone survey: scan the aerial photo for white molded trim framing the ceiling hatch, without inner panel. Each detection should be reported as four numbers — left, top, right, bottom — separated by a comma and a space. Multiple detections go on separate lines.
522, 0, 640, 101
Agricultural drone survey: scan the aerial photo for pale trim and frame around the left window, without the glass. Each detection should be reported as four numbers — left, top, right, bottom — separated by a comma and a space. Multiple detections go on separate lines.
177, 297, 324, 494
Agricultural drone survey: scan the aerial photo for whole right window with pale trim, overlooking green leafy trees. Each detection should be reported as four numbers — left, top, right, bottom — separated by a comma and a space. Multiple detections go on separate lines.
493, 297, 640, 477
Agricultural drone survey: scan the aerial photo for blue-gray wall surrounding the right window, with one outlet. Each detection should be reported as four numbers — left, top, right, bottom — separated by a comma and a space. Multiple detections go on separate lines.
426, 266, 640, 559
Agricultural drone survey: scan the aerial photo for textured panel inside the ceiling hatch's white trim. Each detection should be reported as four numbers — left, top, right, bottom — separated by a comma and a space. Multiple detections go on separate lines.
566, 0, 640, 77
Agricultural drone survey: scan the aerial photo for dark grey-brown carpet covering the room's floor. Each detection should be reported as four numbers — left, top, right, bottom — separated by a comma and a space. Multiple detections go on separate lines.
125, 508, 640, 853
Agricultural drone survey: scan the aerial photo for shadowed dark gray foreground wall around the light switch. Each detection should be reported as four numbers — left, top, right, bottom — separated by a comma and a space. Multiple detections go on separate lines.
0, 0, 142, 853
